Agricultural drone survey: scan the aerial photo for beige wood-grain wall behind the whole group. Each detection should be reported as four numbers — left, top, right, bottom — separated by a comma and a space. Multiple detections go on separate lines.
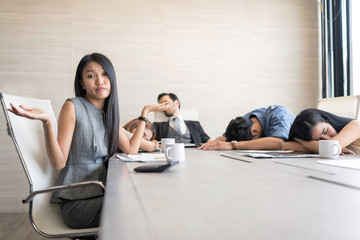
0, 0, 318, 212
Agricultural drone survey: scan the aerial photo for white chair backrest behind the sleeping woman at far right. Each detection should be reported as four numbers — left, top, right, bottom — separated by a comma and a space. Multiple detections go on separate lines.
317, 96, 360, 119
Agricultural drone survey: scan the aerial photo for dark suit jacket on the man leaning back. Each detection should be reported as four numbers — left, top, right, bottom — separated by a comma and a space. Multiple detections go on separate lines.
153, 121, 210, 143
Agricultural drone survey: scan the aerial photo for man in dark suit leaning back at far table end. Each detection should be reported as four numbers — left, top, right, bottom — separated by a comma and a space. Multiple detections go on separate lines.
153, 93, 210, 143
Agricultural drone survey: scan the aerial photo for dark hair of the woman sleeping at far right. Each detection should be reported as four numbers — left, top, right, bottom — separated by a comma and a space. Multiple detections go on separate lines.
289, 108, 353, 141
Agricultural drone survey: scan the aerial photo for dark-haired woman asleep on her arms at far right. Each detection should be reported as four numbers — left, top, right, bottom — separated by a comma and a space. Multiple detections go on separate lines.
289, 109, 360, 154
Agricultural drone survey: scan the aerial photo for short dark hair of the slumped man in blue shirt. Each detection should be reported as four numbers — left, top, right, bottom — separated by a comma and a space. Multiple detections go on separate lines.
225, 117, 254, 142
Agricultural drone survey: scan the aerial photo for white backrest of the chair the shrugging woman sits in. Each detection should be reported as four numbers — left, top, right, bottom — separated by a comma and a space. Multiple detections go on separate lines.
1, 94, 57, 191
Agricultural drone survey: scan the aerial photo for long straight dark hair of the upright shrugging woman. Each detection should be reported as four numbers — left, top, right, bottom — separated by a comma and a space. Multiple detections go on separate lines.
74, 53, 120, 158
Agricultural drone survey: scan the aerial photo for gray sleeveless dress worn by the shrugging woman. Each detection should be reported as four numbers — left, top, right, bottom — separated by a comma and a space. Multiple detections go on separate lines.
51, 97, 108, 228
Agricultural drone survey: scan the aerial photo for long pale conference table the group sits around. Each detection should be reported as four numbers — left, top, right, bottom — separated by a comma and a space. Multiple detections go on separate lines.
100, 148, 360, 240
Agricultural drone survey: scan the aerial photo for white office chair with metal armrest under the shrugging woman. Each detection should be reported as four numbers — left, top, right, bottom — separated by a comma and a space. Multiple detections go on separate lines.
0, 93, 104, 239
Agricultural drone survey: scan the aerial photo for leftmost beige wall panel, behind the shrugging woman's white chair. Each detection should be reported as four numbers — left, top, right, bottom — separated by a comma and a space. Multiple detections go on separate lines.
0, 0, 73, 212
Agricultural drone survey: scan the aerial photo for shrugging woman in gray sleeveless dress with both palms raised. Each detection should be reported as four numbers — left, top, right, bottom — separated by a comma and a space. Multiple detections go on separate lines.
9, 53, 168, 231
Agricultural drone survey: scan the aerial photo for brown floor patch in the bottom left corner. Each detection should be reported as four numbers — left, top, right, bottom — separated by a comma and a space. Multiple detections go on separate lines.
0, 213, 65, 240
